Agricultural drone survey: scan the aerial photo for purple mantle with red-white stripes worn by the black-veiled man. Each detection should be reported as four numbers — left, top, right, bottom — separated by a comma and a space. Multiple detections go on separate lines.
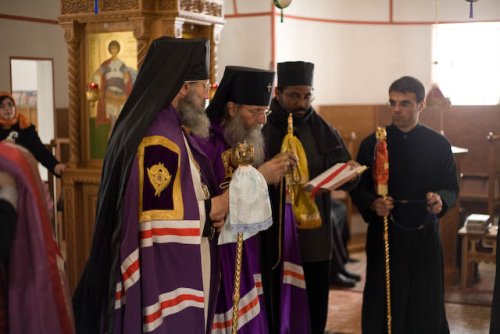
114, 107, 217, 333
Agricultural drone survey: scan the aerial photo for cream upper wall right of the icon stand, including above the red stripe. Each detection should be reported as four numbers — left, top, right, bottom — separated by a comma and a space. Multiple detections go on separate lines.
219, 0, 500, 104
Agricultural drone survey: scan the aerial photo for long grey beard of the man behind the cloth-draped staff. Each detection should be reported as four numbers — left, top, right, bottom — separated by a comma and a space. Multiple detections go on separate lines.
223, 114, 265, 167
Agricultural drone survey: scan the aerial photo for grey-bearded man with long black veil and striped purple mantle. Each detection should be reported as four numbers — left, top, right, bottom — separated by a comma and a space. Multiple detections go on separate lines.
73, 37, 228, 333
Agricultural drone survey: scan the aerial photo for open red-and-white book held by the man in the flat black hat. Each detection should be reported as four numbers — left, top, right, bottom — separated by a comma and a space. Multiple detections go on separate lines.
304, 162, 368, 196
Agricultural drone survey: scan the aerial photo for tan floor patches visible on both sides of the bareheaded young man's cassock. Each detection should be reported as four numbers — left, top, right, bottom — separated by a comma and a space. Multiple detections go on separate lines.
326, 253, 492, 334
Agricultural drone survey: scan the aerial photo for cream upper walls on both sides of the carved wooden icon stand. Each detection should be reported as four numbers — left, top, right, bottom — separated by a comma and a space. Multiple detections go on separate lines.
0, 0, 500, 108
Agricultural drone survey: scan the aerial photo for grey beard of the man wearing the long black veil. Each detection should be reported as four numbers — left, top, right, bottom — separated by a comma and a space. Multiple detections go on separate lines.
178, 90, 210, 138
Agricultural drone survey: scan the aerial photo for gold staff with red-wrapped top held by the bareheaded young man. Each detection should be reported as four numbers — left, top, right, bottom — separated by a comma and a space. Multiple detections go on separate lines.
374, 127, 392, 334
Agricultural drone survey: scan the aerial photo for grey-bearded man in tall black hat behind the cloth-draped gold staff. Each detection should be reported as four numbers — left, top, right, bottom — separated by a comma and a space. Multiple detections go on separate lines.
195, 66, 305, 334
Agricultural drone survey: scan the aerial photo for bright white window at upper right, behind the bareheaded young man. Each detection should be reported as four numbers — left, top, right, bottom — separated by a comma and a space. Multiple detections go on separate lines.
432, 22, 500, 105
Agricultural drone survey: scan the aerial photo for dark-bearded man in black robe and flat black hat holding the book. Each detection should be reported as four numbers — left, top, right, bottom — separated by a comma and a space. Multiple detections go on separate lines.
262, 61, 357, 334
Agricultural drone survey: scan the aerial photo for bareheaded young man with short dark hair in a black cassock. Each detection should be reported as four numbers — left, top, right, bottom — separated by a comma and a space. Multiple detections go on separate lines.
351, 76, 458, 333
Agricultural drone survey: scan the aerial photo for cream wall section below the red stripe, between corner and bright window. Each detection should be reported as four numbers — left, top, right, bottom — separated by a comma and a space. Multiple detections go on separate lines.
277, 22, 431, 104
